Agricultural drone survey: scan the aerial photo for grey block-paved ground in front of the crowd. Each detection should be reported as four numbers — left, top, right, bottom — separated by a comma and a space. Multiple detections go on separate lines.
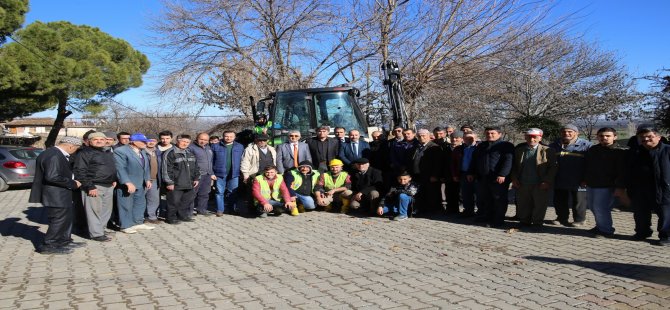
0, 190, 670, 309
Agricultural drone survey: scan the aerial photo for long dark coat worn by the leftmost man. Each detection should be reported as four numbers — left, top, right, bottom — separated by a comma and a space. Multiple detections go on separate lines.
28, 147, 77, 208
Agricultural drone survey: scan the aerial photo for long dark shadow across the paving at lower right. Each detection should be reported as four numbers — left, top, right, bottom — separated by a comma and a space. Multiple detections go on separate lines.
525, 256, 670, 285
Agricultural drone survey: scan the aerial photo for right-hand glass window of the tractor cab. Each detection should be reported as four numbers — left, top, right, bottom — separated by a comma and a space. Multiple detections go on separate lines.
315, 92, 366, 135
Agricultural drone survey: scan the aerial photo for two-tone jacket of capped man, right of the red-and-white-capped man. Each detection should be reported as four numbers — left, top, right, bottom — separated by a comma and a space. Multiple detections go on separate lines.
549, 138, 591, 190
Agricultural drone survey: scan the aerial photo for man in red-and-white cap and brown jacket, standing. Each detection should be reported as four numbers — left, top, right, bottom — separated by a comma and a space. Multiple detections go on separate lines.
511, 128, 558, 228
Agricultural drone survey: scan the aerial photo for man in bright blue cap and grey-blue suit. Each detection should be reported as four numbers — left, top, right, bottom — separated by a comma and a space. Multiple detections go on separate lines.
114, 133, 155, 234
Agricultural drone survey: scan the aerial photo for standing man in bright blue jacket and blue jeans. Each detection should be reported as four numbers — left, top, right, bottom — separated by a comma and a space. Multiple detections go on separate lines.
211, 130, 244, 216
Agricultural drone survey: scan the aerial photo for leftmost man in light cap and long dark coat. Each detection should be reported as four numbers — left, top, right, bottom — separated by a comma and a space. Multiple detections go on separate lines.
28, 137, 83, 254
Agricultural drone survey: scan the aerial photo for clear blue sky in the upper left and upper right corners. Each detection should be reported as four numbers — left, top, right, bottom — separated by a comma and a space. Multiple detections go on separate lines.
25, 0, 670, 116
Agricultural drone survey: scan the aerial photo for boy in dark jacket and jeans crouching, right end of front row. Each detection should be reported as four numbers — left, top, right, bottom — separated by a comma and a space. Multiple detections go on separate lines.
377, 172, 419, 221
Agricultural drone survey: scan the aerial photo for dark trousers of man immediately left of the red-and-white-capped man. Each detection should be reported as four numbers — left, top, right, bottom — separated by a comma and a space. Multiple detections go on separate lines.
477, 178, 509, 225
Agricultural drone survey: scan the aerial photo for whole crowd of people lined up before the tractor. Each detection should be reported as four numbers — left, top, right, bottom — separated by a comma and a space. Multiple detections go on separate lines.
30, 124, 670, 254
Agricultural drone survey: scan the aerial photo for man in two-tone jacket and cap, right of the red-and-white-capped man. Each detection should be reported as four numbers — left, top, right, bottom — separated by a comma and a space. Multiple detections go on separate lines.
549, 124, 591, 226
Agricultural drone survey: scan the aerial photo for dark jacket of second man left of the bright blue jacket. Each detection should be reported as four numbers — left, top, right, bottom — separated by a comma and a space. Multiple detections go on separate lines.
161, 147, 200, 190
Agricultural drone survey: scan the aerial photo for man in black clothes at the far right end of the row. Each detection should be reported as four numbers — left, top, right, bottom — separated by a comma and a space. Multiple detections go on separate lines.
626, 127, 670, 246
